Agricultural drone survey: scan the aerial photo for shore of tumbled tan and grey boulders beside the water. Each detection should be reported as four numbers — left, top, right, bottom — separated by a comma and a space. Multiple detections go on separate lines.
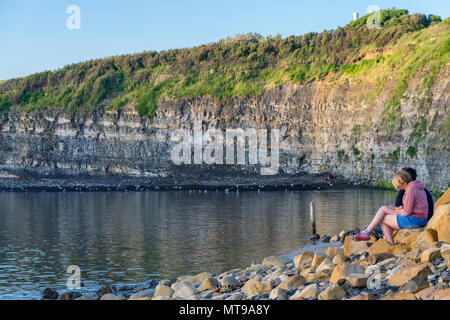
42, 189, 450, 300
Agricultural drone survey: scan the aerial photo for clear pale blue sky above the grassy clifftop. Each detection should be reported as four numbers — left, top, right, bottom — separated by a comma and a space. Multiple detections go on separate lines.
0, 0, 450, 80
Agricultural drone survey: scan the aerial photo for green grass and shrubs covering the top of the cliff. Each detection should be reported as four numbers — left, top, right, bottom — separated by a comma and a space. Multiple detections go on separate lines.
0, 9, 450, 122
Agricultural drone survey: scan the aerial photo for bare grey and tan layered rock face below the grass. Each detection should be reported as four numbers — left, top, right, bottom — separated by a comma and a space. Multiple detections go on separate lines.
0, 67, 450, 189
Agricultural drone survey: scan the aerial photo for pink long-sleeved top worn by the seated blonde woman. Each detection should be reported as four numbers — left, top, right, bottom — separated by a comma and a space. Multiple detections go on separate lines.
400, 180, 428, 219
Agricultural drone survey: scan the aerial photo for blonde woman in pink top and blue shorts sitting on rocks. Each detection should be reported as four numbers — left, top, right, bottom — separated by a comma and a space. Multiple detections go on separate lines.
352, 170, 428, 244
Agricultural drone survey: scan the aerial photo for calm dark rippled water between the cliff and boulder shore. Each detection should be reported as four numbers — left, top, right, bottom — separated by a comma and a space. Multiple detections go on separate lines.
0, 188, 395, 299
